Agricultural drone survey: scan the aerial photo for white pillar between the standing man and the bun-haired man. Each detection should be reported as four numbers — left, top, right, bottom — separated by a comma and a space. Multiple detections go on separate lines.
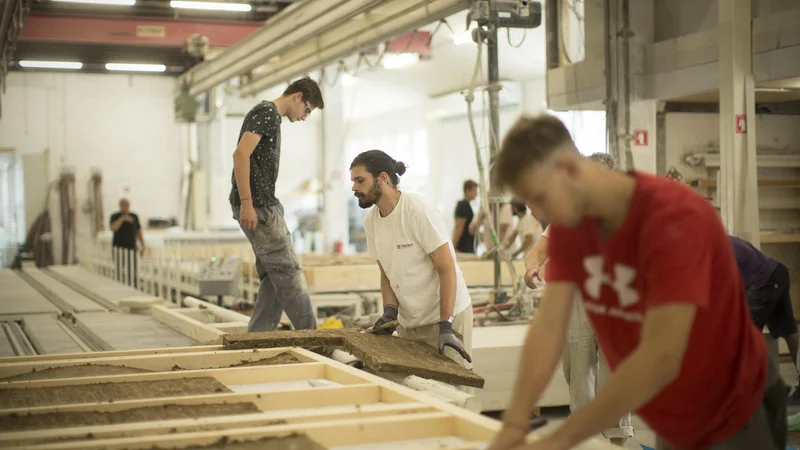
319, 80, 352, 253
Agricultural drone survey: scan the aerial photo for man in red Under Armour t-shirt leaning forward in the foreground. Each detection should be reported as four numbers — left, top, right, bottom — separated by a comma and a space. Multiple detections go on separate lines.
484, 115, 787, 450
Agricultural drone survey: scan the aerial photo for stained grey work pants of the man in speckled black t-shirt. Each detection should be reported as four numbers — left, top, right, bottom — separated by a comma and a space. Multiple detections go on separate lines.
232, 203, 317, 332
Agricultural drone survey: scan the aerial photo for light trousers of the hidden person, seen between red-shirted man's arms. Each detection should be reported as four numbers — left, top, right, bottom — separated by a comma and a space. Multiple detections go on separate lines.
563, 297, 633, 439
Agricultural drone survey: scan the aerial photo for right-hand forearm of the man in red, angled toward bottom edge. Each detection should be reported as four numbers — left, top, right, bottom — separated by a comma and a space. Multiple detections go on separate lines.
554, 347, 672, 446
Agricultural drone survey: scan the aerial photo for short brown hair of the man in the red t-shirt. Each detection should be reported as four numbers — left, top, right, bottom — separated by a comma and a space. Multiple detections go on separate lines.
493, 114, 575, 189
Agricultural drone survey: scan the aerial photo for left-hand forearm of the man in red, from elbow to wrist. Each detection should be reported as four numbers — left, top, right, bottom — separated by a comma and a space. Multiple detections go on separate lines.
503, 312, 566, 427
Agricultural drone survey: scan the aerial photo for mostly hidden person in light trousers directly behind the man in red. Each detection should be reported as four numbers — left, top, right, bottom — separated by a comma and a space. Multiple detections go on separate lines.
525, 153, 634, 446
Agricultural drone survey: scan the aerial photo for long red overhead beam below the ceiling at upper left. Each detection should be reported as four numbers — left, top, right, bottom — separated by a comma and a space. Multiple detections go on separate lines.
20, 14, 262, 47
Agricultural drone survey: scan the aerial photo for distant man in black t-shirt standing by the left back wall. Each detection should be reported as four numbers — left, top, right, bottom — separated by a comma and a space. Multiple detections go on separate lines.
109, 198, 145, 287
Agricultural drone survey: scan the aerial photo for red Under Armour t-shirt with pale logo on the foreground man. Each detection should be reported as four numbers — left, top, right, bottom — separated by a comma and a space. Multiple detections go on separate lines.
546, 172, 767, 449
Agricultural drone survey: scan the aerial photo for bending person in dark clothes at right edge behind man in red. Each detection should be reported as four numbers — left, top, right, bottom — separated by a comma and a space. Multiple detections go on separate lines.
729, 236, 800, 404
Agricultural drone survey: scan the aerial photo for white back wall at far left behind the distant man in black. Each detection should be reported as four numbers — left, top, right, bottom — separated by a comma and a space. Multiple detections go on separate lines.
0, 72, 181, 261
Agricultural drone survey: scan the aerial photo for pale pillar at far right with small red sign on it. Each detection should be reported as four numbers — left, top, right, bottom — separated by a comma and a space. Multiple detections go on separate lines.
717, 0, 760, 245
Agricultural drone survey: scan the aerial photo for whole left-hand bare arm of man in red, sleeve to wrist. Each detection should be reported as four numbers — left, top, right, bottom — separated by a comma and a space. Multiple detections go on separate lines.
503, 282, 575, 430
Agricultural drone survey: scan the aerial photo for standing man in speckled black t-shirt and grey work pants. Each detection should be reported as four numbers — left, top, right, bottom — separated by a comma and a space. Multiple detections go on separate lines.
230, 77, 325, 331
